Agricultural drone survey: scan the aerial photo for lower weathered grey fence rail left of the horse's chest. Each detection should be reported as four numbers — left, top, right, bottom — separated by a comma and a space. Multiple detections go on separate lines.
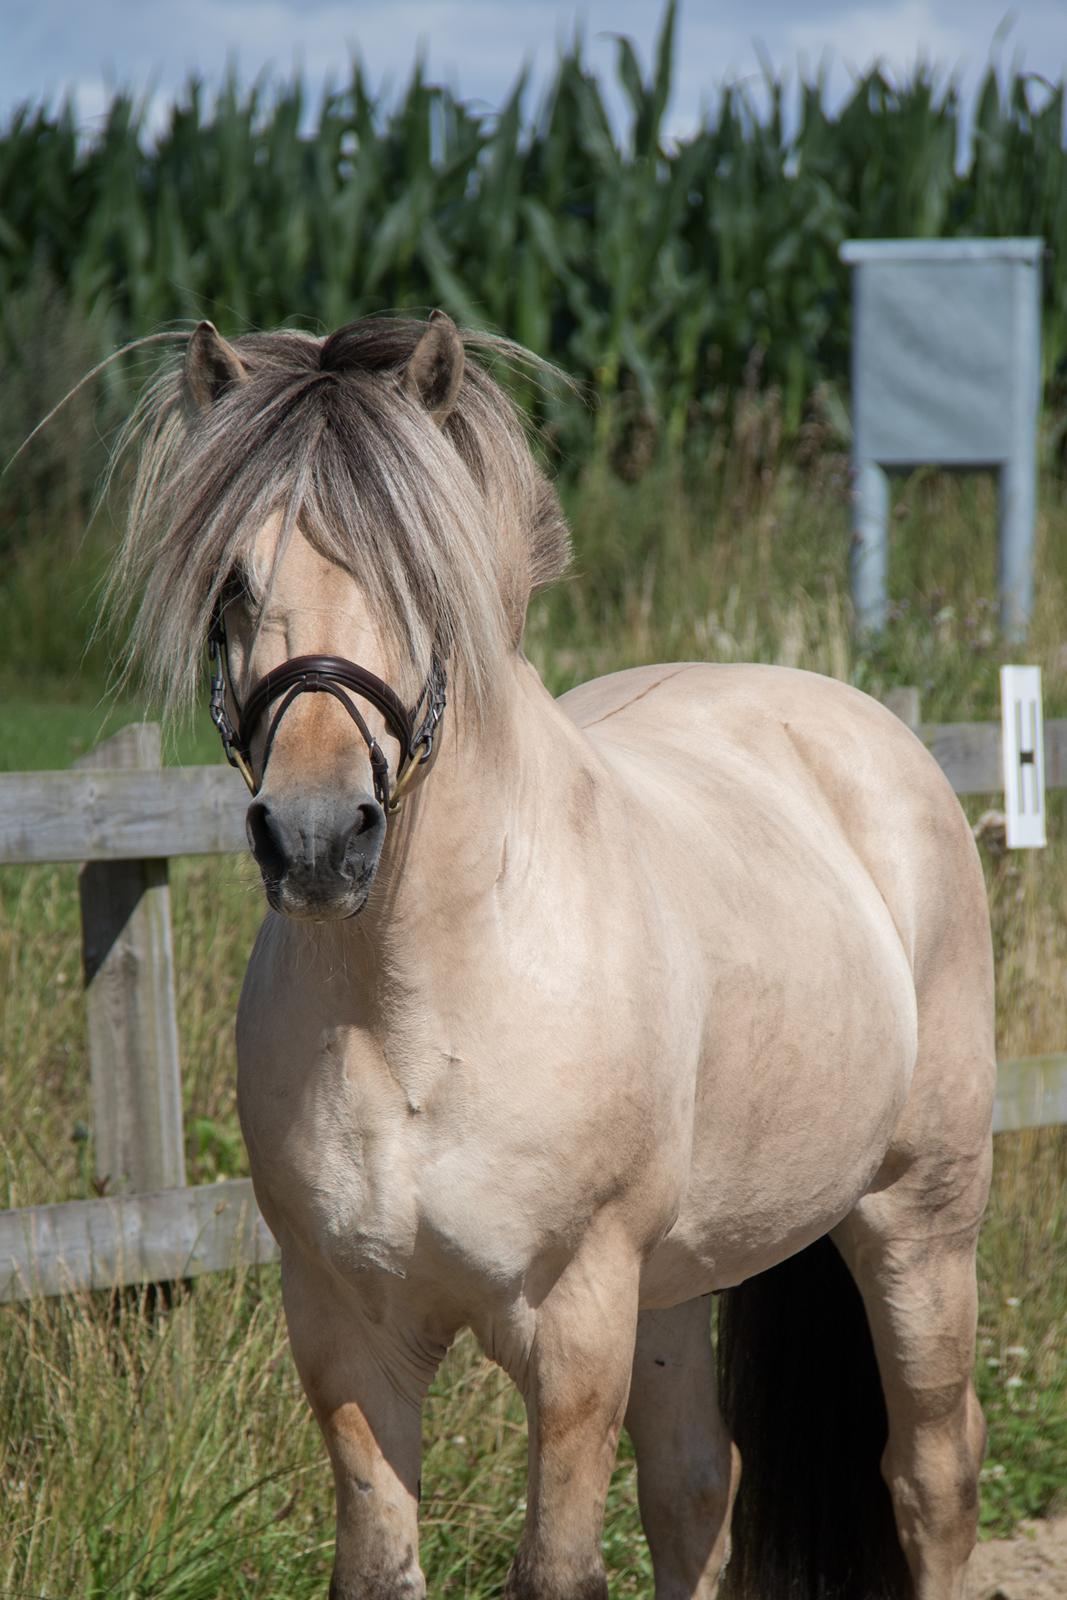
0, 1178, 278, 1302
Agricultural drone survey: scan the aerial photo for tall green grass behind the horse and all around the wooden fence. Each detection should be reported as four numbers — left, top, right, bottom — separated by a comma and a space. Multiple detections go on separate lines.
0, 451, 1067, 1600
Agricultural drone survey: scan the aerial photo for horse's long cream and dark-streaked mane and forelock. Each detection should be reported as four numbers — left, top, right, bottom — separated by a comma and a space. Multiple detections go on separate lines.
109, 318, 569, 710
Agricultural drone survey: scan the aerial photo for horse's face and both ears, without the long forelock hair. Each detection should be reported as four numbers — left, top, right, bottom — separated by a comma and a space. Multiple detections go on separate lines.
191, 314, 464, 922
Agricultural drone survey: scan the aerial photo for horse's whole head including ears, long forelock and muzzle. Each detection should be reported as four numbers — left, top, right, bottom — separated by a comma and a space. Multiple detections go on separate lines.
112, 314, 566, 920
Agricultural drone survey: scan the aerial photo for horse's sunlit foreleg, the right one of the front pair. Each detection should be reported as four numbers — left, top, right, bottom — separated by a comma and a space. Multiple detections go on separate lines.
506, 1250, 640, 1600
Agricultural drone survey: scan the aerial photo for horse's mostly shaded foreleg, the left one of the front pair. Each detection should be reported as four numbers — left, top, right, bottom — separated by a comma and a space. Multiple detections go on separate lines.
282, 1258, 443, 1600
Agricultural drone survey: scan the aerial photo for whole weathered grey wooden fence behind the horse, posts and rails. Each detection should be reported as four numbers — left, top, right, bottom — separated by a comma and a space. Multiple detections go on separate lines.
0, 707, 1067, 1301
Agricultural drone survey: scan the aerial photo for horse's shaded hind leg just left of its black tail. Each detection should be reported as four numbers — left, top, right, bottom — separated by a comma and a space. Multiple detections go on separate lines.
625, 1298, 741, 1600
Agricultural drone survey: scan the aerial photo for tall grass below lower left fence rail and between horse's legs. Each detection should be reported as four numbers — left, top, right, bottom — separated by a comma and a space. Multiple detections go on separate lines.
0, 1269, 651, 1600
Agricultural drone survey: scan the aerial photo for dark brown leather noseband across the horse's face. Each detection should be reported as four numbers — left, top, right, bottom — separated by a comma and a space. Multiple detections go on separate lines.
208, 608, 448, 811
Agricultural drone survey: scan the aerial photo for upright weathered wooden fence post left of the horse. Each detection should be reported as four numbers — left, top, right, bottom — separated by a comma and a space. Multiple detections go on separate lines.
77, 722, 186, 1194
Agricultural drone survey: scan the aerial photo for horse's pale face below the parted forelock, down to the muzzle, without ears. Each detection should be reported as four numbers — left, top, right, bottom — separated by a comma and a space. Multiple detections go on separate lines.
216, 514, 414, 920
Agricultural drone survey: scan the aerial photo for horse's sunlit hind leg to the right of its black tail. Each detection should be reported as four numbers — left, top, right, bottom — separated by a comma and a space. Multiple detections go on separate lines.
833, 1049, 990, 1600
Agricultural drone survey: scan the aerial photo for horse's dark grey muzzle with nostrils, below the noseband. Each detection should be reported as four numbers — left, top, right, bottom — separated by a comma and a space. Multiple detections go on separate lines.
245, 792, 386, 922
